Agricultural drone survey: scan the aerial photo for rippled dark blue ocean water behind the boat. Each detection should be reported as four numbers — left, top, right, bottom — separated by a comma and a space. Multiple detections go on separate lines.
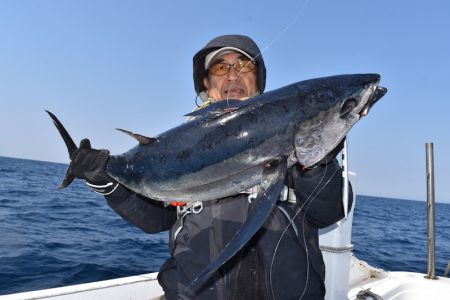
0, 157, 450, 295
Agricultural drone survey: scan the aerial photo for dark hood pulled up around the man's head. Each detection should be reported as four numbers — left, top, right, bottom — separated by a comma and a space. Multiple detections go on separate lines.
193, 34, 266, 94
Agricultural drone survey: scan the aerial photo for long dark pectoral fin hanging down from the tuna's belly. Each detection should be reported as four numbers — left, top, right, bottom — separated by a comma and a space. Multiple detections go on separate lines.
185, 157, 287, 294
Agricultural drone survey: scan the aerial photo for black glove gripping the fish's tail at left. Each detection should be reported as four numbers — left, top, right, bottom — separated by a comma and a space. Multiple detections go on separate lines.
69, 139, 118, 195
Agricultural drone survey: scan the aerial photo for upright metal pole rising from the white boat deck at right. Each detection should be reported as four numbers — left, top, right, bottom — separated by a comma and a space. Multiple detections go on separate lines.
425, 143, 438, 279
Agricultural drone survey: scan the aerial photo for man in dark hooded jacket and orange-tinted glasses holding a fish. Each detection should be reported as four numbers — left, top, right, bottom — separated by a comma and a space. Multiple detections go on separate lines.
70, 35, 353, 300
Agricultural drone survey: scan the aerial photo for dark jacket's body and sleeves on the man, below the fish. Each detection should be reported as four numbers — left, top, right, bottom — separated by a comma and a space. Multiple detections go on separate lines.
106, 160, 353, 300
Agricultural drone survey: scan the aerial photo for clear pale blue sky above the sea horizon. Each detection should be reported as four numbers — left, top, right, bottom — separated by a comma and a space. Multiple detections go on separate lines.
0, 0, 450, 202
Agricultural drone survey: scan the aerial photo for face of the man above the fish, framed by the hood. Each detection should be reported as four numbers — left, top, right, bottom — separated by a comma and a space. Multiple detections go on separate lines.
203, 52, 259, 101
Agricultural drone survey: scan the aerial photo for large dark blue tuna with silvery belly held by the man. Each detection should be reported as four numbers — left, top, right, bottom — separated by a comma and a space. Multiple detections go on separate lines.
49, 74, 386, 289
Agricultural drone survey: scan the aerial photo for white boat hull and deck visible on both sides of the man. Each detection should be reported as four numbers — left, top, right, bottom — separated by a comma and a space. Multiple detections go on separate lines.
0, 258, 450, 300
